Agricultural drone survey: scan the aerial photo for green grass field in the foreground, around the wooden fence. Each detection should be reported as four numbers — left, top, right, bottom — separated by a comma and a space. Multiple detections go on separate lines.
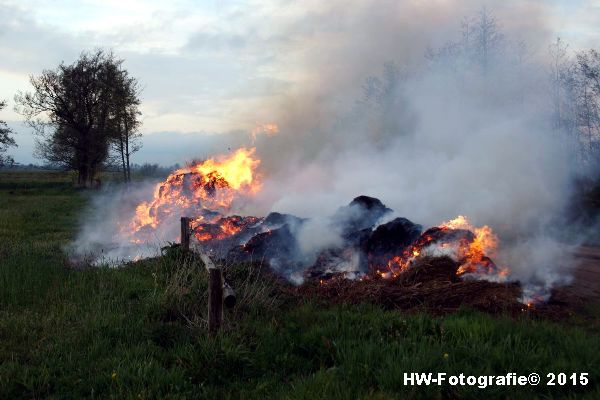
0, 172, 600, 399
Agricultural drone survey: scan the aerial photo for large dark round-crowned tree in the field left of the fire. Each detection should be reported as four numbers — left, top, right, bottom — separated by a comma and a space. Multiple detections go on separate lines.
15, 50, 139, 187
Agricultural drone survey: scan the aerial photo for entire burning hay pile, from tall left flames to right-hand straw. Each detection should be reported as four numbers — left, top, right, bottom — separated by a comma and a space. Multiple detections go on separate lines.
118, 149, 540, 307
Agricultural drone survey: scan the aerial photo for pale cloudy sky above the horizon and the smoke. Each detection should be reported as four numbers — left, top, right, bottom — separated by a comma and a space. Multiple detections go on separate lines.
0, 0, 600, 165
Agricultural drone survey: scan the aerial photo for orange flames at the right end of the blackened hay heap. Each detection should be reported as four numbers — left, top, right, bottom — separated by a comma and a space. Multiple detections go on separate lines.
378, 215, 509, 278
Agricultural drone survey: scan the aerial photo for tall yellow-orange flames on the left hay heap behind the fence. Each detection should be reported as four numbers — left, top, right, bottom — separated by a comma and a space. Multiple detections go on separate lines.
124, 148, 261, 242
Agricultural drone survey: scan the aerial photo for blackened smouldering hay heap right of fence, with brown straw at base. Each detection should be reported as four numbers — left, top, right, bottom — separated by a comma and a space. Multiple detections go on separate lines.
183, 196, 520, 308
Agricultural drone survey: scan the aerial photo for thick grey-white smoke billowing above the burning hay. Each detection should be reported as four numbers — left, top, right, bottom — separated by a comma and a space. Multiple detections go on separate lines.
69, 1, 592, 296
